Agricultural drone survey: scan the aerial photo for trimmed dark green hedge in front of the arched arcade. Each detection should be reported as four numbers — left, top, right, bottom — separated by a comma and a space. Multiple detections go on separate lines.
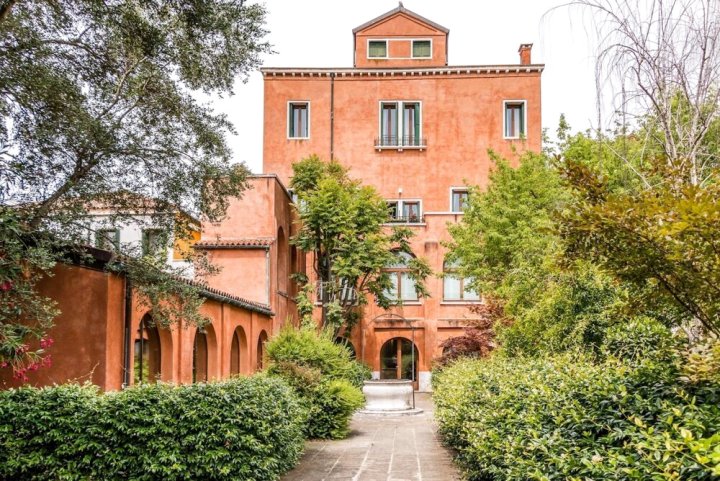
0, 377, 306, 480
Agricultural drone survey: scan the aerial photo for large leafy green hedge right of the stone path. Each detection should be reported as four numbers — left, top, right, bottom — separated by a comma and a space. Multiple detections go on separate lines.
433, 350, 720, 481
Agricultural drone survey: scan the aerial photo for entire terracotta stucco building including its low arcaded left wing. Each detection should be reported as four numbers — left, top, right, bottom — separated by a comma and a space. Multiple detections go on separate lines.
0, 4, 543, 390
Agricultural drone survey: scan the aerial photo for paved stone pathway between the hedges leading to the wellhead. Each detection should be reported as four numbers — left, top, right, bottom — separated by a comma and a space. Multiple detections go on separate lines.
282, 394, 461, 481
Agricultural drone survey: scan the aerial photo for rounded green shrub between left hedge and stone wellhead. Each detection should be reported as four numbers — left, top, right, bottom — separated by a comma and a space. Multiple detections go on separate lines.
267, 326, 370, 439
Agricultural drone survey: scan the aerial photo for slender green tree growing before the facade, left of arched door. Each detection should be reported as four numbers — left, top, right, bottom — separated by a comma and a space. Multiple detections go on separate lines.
290, 156, 431, 332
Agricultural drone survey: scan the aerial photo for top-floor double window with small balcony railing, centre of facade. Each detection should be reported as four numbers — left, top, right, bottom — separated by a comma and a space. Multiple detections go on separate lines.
376, 101, 425, 147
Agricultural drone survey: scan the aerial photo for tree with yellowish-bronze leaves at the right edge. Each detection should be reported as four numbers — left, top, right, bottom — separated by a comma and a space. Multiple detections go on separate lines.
563, 162, 720, 334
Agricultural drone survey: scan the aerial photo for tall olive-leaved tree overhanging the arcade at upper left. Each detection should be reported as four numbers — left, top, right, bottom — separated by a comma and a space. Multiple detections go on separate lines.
0, 0, 269, 374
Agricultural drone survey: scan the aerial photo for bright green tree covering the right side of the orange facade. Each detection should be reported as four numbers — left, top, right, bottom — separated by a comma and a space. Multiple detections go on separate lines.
450, 153, 622, 354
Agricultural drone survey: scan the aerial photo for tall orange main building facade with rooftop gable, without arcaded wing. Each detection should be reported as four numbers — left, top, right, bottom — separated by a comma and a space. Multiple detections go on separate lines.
262, 5, 543, 390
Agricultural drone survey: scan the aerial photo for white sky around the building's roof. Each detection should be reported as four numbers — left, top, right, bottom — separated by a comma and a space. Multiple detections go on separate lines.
214, 0, 597, 173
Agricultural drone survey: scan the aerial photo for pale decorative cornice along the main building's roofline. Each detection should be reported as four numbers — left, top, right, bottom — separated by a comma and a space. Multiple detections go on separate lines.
260, 64, 545, 78
